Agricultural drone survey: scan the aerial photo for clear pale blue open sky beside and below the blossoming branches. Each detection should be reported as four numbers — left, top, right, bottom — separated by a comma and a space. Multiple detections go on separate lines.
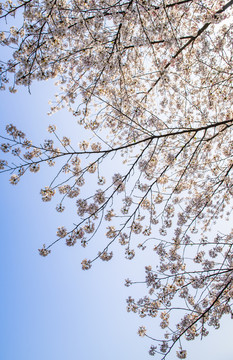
0, 82, 233, 360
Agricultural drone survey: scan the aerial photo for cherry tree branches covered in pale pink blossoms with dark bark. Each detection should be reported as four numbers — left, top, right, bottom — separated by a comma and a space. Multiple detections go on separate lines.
0, 0, 233, 359
